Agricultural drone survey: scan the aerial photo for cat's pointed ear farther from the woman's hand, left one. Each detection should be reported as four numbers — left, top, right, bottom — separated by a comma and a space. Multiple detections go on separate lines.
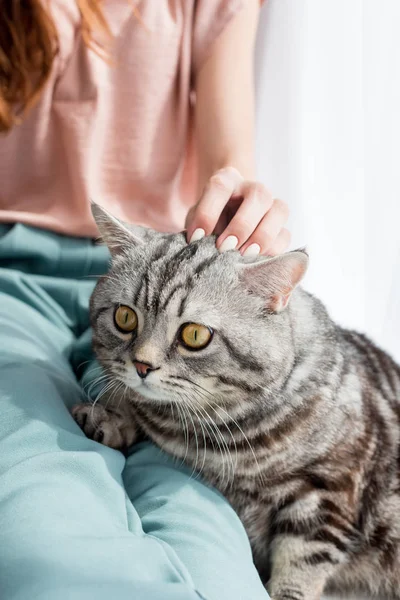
91, 202, 144, 254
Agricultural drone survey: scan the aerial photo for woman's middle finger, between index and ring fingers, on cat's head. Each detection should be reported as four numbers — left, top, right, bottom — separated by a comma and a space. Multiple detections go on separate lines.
217, 182, 273, 252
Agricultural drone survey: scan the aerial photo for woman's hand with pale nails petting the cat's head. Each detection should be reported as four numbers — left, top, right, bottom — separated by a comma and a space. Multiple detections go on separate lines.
186, 167, 290, 256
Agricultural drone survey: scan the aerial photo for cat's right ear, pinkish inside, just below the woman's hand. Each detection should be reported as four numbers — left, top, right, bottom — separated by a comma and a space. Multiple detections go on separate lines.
239, 249, 308, 312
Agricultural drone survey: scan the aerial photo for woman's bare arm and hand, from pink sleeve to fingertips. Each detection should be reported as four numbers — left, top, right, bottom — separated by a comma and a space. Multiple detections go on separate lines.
187, 0, 290, 255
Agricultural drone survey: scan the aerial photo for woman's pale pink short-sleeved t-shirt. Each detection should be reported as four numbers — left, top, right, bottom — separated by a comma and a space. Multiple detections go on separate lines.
0, 0, 243, 236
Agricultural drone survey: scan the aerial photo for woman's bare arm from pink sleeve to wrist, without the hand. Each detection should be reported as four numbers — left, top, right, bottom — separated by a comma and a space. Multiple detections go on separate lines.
196, 0, 259, 192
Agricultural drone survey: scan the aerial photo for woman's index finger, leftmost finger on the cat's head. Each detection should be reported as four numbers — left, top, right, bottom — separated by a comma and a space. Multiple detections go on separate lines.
186, 167, 243, 242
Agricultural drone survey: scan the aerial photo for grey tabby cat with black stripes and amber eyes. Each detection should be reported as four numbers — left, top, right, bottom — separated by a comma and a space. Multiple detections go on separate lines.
72, 205, 400, 600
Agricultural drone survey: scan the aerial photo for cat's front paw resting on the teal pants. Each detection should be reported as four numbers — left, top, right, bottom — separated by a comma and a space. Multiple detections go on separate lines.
71, 402, 137, 450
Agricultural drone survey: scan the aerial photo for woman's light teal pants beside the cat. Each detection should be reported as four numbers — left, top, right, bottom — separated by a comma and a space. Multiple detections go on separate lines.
0, 224, 268, 600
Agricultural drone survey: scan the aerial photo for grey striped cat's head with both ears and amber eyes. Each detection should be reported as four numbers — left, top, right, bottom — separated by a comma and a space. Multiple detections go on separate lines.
91, 205, 308, 406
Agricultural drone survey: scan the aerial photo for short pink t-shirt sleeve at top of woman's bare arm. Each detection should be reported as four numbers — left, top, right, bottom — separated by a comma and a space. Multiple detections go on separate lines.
192, 0, 246, 73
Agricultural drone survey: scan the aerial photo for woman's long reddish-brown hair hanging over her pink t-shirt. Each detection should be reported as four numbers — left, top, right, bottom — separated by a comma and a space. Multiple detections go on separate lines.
0, 0, 110, 132
